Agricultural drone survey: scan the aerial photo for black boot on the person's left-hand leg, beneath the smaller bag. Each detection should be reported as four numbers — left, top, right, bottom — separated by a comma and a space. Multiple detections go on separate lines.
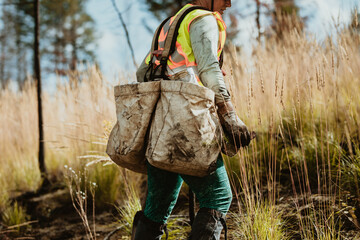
131, 211, 168, 240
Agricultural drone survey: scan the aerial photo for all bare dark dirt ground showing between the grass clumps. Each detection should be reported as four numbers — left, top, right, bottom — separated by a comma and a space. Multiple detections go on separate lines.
0, 184, 360, 240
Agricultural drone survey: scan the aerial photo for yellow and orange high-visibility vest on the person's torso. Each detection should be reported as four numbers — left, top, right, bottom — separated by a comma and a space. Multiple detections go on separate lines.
146, 4, 226, 84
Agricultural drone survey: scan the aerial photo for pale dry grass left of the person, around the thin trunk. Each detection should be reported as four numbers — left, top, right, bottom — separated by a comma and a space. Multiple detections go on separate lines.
0, 67, 120, 204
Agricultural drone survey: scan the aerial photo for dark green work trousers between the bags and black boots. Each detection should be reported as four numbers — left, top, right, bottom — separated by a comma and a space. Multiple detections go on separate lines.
144, 154, 232, 224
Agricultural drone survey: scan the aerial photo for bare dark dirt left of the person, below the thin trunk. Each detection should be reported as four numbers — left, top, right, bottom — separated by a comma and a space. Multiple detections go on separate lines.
0, 189, 126, 240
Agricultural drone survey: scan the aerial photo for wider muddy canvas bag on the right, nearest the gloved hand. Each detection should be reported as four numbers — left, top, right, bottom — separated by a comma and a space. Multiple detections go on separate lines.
146, 81, 221, 177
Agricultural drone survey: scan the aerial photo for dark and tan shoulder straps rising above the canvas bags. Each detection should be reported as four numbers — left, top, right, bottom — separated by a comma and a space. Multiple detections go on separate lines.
144, 6, 208, 82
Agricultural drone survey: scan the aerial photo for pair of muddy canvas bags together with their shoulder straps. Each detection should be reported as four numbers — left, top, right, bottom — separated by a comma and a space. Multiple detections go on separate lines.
106, 6, 221, 176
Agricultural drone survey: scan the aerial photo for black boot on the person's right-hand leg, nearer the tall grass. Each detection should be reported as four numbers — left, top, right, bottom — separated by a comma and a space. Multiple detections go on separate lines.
189, 208, 227, 240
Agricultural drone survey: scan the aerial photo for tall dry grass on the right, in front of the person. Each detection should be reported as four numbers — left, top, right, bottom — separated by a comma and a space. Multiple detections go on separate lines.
226, 23, 360, 239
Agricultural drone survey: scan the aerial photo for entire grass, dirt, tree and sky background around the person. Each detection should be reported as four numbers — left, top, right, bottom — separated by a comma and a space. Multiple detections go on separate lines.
0, 0, 360, 239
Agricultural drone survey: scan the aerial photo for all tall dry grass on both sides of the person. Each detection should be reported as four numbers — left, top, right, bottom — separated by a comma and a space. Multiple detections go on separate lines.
0, 16, 360, 239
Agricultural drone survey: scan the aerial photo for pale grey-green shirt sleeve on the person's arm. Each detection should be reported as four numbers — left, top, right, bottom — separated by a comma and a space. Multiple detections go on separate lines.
190, 15, 230, 104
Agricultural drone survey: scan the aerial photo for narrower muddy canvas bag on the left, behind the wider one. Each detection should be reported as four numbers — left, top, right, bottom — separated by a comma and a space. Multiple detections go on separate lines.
106, 82, 160, 173
